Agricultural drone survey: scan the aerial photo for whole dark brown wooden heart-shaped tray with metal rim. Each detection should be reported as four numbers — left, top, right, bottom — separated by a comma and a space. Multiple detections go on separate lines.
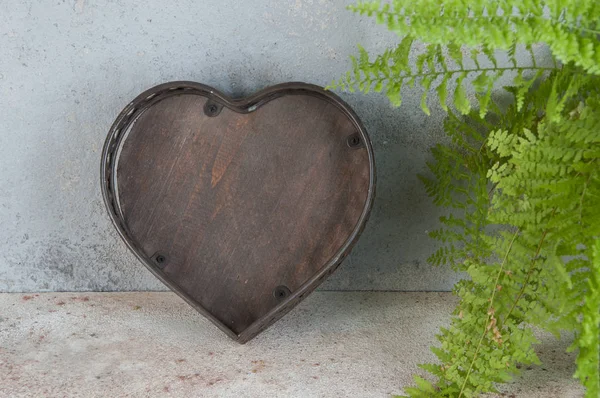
101, 81, 375, 343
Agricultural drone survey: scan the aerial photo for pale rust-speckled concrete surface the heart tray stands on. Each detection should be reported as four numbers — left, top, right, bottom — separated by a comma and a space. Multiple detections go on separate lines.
0, 292, 583, 398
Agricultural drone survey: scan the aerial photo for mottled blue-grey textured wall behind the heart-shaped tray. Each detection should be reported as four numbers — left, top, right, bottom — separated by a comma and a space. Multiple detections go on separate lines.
0, 0, 456, 291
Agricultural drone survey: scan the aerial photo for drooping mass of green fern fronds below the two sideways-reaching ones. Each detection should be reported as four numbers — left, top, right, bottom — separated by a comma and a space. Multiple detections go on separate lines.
407, 68, 600, 397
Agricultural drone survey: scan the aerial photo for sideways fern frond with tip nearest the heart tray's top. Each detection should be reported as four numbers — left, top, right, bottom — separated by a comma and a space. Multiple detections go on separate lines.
328, 36, 554, 117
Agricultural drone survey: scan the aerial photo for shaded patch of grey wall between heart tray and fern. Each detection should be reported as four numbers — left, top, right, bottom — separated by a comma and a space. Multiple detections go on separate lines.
322, 94, 459, 291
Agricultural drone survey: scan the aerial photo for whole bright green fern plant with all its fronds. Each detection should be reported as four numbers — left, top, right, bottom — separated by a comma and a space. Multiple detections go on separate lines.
332, 0, 600, 398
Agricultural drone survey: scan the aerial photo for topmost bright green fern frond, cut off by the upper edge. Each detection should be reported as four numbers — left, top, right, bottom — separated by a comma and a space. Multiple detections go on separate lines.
348, 0, 600, 74
